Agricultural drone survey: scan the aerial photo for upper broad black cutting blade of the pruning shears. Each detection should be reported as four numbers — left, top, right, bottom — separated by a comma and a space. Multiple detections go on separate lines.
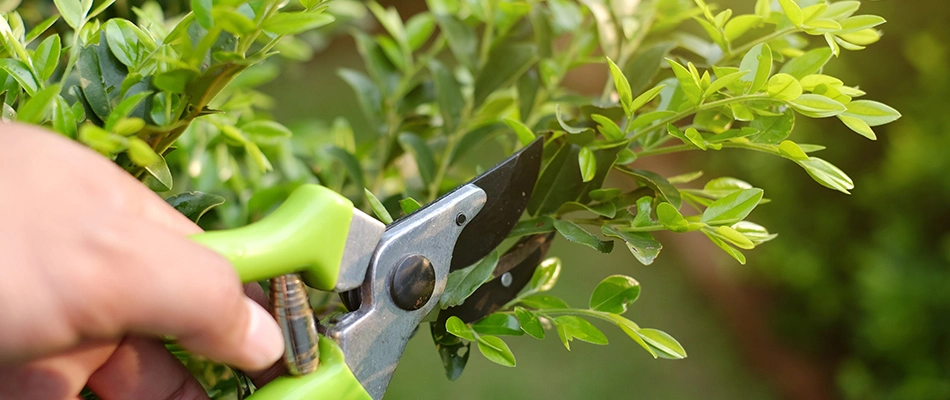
450, 138, 544, 271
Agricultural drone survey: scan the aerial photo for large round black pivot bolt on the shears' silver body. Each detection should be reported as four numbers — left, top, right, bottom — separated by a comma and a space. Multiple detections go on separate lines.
389, 254, 435, 311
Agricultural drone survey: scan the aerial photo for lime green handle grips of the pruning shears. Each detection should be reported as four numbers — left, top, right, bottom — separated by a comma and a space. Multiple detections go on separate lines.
192, 185, 370, 400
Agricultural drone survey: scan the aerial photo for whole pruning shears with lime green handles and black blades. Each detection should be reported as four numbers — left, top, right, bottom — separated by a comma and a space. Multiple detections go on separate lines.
194, 139, 553, 400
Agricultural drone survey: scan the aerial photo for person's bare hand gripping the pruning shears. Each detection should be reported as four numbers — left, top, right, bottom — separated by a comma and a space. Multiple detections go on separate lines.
0, 123, 283, 399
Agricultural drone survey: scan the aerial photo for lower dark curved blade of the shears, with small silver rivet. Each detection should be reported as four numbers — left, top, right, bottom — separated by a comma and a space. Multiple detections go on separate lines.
437, 232, 555, 326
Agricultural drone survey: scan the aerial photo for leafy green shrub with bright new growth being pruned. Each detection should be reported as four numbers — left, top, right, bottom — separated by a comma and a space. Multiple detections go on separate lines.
0, 0, 900, 396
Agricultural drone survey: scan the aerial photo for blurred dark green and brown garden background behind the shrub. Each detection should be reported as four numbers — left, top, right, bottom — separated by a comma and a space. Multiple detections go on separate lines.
256, 0, 950, 400
